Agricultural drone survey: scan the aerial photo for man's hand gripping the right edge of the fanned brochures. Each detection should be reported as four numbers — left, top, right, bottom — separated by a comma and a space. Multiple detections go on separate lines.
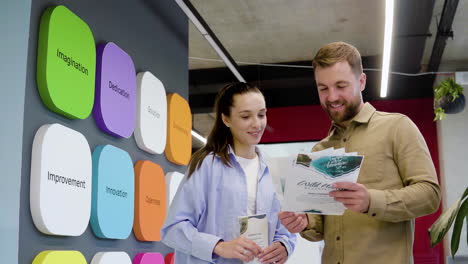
329, 182, 370, 213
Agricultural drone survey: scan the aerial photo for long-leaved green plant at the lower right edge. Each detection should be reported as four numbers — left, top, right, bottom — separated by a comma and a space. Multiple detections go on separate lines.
428, 187, 468, 258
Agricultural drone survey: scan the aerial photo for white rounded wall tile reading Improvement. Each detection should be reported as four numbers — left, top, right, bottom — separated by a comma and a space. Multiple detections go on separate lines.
30, 124, 92, 236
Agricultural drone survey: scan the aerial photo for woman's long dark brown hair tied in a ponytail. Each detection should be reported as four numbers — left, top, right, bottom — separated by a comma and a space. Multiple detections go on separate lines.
188, 82, 262, 178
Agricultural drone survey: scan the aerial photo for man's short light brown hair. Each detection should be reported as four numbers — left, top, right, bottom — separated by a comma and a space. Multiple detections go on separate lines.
312, 42, 362, 76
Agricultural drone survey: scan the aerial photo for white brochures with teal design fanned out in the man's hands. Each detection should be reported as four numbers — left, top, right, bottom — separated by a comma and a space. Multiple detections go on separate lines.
283, 148, 364, 215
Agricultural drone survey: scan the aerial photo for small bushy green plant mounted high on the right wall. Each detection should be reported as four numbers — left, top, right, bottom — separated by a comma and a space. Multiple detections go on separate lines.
434, 78, 465, 121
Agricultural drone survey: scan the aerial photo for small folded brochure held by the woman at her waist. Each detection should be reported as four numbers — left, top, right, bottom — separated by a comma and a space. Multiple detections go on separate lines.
239, 214, 268, 264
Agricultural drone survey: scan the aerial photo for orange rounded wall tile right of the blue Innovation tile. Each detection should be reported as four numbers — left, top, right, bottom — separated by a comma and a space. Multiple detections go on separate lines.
133, 160, 166, 241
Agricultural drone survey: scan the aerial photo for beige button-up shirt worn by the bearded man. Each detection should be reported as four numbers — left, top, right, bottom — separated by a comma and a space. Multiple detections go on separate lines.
301, 103, 440, 264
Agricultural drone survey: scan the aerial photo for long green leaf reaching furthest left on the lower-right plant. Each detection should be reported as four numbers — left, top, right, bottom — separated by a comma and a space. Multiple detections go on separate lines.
428, 188, 468, 247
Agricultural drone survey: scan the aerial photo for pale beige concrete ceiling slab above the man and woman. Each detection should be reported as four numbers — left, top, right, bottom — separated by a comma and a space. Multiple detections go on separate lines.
189, 0, 385, 69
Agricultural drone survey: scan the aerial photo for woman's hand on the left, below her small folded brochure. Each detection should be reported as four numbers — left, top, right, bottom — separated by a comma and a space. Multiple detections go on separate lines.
214, 237, 262, 262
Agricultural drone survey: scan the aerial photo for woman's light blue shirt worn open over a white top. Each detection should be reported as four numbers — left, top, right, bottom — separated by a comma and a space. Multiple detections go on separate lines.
161, 148, 296, 264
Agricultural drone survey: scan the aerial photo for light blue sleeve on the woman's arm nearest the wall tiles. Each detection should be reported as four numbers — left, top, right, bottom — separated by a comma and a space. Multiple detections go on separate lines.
161, 162, 221, 262
